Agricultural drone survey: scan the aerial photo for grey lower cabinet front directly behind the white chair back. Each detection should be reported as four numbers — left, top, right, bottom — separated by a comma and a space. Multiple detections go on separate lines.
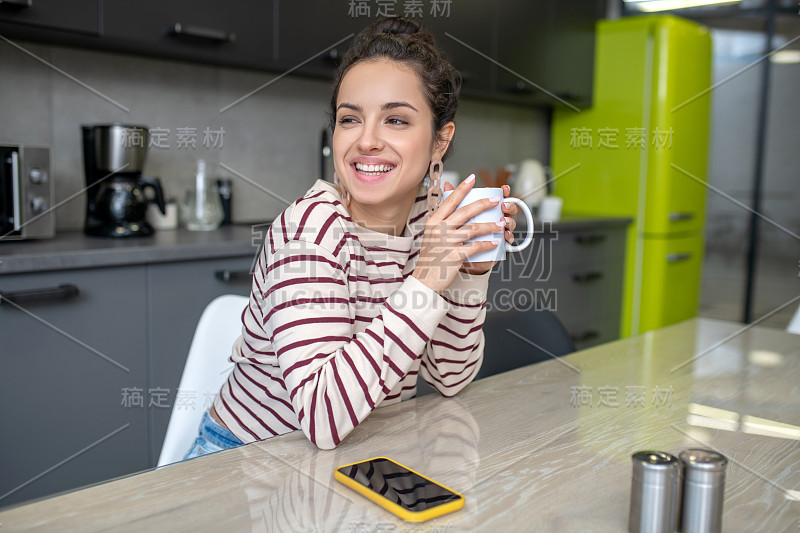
147, 257, 253, 466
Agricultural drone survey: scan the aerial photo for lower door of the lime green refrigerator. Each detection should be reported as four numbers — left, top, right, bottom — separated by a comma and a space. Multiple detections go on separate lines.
639, 236, 703, 331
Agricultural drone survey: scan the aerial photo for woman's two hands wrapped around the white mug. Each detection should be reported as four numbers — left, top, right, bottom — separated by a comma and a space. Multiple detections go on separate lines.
412, 175, 517, 293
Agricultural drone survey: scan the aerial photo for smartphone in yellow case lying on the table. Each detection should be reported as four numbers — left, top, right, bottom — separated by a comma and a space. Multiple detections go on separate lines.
333, 457, 464, 522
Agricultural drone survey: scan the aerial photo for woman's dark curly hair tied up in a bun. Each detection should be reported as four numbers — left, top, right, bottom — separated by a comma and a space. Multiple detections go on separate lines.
330, 17, 461, 159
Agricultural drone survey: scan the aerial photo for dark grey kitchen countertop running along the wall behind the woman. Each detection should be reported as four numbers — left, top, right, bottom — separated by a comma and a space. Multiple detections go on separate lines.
0, 217, 630, 275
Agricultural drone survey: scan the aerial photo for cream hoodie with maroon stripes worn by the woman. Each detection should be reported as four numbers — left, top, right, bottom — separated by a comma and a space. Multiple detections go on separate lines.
214, 180, 489, 449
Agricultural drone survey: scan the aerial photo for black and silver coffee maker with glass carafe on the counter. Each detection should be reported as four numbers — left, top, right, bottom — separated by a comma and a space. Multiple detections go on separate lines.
81, 124, 166, 237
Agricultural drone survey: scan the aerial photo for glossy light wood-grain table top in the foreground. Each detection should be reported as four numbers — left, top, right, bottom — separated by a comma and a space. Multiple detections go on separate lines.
0, 319, 800, 532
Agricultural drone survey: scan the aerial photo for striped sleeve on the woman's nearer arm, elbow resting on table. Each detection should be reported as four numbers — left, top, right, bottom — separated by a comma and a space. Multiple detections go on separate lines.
259, 240, 450, 449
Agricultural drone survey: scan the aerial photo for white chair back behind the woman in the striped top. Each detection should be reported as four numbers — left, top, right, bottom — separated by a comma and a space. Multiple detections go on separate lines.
158, 294, 248, 466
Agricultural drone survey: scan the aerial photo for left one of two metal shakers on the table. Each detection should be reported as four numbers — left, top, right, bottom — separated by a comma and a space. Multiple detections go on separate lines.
628, 451, 680, 533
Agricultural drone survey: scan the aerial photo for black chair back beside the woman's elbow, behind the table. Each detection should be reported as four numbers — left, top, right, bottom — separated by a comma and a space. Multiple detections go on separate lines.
476, 309, 575, 379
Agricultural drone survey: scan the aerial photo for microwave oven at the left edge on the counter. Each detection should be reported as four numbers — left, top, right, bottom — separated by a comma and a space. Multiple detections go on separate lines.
0, 143, 56, 242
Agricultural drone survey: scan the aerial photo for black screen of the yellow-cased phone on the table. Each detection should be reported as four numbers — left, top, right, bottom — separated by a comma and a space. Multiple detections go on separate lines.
339, 458, 461, 512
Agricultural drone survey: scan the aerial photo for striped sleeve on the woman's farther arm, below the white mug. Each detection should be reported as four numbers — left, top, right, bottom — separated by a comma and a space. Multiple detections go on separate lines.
420, 271, 491, 396
